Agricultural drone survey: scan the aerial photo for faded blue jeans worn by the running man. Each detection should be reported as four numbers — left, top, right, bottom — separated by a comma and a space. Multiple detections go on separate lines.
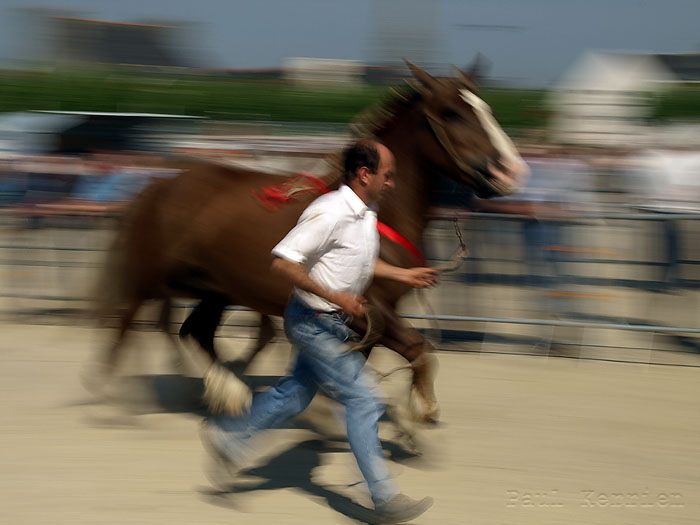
214, 296, 399, 504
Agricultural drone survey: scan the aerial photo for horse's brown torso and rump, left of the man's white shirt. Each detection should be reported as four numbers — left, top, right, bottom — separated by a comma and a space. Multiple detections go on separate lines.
116, 161, 311, 314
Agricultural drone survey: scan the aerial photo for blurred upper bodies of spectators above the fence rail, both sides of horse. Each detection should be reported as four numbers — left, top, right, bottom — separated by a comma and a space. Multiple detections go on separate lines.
0, 143, 700, 211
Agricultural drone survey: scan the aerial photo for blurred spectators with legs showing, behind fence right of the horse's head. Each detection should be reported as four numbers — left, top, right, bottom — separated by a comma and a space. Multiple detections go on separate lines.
472, 147, 700, 292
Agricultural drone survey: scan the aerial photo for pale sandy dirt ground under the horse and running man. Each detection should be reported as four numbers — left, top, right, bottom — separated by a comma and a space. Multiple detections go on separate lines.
0, 324, 700, 525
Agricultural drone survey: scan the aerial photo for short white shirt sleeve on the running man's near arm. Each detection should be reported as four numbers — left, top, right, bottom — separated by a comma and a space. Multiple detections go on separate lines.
272, 207, 337, 264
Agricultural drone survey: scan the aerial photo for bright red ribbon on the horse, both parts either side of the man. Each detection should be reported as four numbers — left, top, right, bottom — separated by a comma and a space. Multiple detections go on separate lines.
253, 173, 425, 266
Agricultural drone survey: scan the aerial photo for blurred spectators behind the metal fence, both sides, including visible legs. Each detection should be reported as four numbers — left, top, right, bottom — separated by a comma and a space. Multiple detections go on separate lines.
0, 138, 700, 290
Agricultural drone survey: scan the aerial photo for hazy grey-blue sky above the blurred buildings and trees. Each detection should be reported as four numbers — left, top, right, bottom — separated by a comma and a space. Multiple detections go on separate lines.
0, 0, 700, 86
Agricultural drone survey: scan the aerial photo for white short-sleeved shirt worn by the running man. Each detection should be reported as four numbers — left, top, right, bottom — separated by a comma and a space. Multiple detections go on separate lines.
272, 185, 379, 311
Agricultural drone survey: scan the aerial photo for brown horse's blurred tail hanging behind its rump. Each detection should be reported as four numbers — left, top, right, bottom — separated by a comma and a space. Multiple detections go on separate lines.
92, 179, 167, 322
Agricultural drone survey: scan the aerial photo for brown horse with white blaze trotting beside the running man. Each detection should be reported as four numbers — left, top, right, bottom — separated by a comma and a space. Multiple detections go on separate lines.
95, 64, 524, 421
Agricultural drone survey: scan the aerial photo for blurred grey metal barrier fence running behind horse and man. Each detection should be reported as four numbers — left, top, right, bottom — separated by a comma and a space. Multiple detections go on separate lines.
0, 208, 700, 364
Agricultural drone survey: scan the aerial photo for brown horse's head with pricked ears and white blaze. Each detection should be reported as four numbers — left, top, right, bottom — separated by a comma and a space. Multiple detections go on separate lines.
408, 62, 527, 198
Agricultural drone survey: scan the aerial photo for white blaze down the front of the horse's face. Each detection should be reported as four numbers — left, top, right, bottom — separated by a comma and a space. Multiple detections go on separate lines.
459, 89, 527, 185
